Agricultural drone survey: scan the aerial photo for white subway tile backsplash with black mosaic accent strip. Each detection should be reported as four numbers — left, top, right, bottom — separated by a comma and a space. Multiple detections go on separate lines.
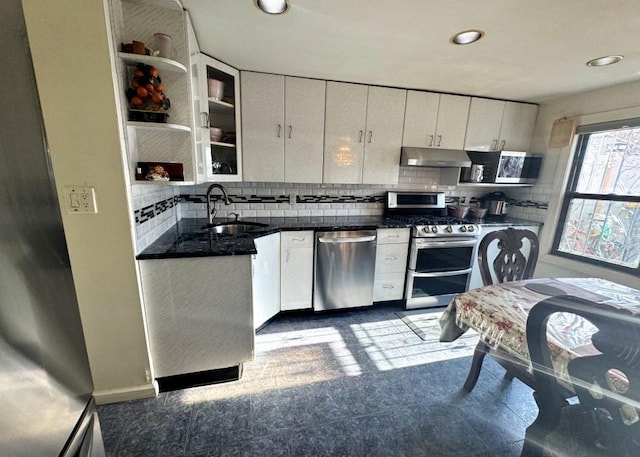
132, 167, 551, 252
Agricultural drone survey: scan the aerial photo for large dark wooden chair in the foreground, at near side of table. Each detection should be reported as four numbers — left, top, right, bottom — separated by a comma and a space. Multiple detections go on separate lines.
522, 295, 640, 457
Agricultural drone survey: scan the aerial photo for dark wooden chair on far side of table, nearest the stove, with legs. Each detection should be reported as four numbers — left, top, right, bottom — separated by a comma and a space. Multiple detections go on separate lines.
464, 228, 539, 392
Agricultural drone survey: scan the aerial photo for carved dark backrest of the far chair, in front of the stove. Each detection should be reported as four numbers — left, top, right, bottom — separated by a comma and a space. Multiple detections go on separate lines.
478, 227, 539, 286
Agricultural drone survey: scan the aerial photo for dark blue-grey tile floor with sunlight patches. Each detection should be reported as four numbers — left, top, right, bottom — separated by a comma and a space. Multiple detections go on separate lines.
99, 305, 537, 457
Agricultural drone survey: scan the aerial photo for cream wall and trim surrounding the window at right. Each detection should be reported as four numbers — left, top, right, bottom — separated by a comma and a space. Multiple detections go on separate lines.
532, 82, 640, 287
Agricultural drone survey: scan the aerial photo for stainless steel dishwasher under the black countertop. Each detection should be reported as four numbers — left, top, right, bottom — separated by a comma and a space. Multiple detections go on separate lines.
313, 230, 376, 311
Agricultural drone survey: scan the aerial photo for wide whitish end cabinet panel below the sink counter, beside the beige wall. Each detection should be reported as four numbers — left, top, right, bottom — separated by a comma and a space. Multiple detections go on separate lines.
139, 255, 254, 378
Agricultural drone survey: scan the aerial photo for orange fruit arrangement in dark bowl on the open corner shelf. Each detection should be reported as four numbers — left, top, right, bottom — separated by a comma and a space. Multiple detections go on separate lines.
127, 63, 171, 122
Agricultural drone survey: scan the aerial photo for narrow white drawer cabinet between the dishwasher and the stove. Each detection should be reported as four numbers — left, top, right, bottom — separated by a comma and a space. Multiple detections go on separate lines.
373, 228, 409, 301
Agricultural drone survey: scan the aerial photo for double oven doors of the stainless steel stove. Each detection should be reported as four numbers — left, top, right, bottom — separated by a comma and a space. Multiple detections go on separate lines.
405, 237, 478, 309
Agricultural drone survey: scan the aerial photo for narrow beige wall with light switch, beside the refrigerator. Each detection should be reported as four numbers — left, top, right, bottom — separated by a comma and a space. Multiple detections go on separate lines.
22, 0, 154, 401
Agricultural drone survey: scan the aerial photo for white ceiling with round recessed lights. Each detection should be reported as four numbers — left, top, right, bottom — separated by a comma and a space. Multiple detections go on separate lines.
182, 0, 640, 102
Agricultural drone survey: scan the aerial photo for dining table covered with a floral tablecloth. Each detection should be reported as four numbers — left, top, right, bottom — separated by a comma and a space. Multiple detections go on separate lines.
440, 278, 640, 388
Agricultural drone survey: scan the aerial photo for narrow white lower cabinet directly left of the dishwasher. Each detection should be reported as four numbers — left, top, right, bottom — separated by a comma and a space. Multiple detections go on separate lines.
280, 230, 314, 311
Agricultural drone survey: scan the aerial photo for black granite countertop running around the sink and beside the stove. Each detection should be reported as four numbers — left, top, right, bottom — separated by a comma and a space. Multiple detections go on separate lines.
136, 216, 539, 260
